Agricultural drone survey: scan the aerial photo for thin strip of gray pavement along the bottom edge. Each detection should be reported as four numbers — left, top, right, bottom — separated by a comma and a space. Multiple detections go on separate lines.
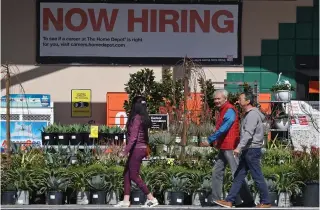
1, 205, 319, 210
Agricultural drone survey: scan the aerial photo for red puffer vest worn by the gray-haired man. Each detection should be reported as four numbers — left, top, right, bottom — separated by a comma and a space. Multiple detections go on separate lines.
216, 102, 240, 150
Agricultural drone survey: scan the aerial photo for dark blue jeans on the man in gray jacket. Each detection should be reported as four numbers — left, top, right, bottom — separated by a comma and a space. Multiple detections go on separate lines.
226, 148, 270, 204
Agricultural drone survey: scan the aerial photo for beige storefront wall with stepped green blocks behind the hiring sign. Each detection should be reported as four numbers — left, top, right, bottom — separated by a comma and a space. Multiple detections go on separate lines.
1, 0, 319, 123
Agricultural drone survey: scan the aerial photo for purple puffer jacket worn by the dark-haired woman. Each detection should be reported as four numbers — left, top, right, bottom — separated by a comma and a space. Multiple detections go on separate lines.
124, 115, 148, 154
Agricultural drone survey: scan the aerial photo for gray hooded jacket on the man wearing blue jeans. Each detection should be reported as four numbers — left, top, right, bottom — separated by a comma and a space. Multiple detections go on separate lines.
237, 108, 265, 151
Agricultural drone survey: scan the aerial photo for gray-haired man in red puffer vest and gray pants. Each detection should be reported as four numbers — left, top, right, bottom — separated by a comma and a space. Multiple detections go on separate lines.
202, 90, 255, 207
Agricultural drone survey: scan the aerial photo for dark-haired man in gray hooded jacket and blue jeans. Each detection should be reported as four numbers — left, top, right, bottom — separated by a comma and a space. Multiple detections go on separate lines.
214, 93, 271, 208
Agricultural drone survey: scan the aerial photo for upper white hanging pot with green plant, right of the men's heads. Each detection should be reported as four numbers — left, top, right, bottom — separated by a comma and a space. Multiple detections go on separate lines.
270, 81, 294, 102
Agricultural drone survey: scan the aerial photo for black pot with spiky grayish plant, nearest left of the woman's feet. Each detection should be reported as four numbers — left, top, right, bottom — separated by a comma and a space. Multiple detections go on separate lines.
87, 174, 108, 204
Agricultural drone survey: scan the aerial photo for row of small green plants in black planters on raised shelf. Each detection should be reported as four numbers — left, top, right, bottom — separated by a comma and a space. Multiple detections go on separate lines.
42, 123, 124, 145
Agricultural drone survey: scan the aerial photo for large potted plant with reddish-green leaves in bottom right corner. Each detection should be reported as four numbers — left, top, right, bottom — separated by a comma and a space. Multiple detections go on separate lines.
294, 147, 319, 207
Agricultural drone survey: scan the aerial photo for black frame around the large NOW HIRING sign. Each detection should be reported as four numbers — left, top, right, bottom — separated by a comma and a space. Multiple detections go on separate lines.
36, 0, 242, 66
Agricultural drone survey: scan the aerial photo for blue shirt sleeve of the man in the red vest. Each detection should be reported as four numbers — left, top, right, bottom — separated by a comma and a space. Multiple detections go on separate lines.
208, 109, 236, 144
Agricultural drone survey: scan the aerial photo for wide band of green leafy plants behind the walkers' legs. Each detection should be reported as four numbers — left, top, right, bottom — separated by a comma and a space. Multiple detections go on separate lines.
1, 142, 319, 203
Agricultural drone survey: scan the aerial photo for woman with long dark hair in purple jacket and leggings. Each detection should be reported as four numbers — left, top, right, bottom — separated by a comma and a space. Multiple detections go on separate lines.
115, 96, 159, 207
